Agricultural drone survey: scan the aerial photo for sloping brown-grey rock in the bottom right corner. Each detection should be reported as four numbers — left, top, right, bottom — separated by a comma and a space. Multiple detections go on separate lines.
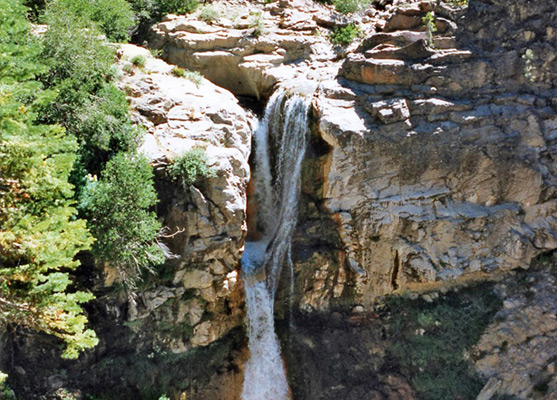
475, 261, 557, 399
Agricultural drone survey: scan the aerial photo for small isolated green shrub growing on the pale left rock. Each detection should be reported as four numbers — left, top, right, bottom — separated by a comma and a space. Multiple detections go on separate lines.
169, 148, 216, 188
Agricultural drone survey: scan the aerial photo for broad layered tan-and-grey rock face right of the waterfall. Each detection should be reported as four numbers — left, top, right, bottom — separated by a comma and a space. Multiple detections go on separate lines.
310, 1, 557, 305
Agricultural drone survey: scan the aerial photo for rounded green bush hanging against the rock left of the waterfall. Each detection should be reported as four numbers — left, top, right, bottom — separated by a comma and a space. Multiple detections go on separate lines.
81, 153, 164, 288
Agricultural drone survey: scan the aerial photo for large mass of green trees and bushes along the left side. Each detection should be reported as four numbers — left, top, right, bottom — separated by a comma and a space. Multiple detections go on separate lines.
0, 0, 162, 366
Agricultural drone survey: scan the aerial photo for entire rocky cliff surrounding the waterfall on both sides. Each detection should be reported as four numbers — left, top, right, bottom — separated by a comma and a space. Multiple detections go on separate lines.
0, 0, 557, 400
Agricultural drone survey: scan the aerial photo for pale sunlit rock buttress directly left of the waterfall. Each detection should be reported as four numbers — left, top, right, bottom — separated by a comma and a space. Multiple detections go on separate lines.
115, 45, 253, 353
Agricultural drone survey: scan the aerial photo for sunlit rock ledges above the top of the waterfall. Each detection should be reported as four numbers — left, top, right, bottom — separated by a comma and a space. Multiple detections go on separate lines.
149, 0, 343, 99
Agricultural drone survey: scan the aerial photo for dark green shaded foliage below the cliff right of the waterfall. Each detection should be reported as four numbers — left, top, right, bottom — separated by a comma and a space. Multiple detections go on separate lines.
386, 285, 501, 400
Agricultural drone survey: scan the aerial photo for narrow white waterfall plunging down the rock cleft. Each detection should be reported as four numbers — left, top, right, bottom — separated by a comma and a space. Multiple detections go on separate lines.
242, 88, 313, 400
